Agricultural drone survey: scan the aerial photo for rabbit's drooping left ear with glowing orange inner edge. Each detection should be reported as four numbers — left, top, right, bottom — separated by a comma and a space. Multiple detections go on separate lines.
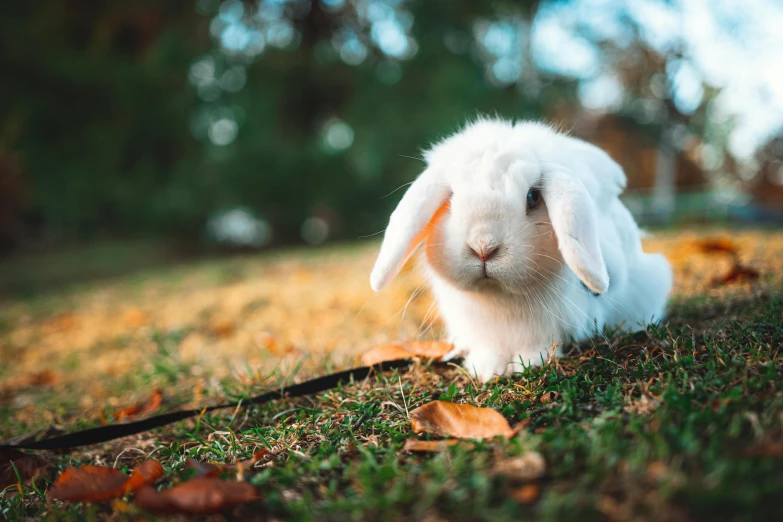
370, 169, 451, 292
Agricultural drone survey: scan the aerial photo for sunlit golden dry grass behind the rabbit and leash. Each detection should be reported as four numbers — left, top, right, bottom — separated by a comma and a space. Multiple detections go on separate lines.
0, 231, 783, 426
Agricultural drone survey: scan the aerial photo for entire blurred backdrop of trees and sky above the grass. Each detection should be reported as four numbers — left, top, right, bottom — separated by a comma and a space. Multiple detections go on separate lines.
0, 0, 783, 291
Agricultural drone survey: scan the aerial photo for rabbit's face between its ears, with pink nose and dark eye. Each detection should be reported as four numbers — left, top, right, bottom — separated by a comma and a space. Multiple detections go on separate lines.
425, 160, 562, 295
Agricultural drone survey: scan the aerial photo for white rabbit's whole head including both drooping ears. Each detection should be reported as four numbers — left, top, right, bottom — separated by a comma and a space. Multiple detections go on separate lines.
370, 119, 625, 294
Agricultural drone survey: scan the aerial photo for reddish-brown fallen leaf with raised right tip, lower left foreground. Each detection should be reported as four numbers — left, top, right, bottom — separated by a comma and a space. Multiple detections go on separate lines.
49, 460, 163, 502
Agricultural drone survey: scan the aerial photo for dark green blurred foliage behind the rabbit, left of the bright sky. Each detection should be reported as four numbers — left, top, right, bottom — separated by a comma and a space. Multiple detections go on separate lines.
0, 0, 564, 248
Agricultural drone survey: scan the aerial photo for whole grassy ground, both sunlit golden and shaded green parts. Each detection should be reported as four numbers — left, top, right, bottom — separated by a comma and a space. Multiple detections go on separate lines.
0, 230, 783, 520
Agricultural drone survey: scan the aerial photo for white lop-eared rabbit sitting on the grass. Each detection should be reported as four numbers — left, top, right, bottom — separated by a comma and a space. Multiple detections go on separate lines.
370, 119, 672, 381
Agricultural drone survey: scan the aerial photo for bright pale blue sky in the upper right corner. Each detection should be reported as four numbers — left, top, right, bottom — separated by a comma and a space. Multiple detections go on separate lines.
531, 0, 783, 158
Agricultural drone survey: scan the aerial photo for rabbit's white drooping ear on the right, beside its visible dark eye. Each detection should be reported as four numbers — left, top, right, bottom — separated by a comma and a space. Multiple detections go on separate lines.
542, 169, 609, 294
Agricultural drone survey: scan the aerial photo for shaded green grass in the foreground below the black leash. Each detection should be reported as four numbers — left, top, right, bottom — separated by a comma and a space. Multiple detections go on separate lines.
0, 290, 783, 520
